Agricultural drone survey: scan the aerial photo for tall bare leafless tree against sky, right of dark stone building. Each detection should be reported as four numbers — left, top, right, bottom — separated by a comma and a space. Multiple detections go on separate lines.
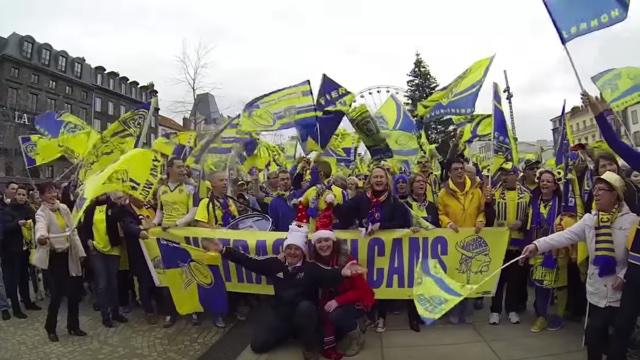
170, 40, 216, 125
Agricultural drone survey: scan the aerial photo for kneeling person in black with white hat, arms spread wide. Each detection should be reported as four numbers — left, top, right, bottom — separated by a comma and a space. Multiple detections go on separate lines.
204, 224, 366, 359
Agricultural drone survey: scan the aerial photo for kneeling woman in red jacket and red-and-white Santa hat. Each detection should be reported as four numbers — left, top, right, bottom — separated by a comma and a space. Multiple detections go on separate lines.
311, 220, 375, 360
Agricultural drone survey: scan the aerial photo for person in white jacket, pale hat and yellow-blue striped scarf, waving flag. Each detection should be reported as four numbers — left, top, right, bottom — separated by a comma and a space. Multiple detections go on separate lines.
522, 171, 638, 360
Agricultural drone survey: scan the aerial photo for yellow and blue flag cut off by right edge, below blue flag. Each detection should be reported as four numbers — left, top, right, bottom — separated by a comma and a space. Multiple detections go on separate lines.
591, 66, 640, 111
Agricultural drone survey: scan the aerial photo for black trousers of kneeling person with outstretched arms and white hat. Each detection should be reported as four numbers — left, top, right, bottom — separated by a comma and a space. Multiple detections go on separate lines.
251, 300, 320, 354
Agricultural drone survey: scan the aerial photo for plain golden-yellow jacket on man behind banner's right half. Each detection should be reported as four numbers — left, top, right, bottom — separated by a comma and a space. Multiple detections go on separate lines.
438, 178, 485, 228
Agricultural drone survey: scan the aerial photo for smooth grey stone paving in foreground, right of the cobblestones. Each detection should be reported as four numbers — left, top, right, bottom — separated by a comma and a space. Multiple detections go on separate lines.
237, 310, 586, 360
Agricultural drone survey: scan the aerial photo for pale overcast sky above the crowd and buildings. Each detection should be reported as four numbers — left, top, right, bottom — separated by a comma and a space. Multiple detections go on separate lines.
0, 0, 640, 140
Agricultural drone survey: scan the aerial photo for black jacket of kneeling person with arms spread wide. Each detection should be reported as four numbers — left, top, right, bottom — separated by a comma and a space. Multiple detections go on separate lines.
222, 247, 342, 315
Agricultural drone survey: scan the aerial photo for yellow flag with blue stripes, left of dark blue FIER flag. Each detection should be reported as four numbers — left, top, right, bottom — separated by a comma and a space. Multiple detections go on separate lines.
239, 80, 318, 132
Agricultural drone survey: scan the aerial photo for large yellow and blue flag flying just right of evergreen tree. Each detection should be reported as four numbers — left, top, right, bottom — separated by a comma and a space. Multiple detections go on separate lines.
416, 56, 494, 121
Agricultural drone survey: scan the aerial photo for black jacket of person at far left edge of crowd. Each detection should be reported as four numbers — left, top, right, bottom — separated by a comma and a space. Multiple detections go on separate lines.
0, 202, 36, 255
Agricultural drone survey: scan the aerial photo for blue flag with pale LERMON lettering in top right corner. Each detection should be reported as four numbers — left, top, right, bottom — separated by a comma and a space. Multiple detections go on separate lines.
543, 0, 629, 44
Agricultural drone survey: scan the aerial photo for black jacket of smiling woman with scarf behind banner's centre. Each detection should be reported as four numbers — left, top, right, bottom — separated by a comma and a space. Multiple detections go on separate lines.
333, 193, 411, 230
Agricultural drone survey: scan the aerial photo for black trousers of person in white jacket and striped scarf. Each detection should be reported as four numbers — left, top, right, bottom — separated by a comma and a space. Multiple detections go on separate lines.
584, 304, 619, 360
